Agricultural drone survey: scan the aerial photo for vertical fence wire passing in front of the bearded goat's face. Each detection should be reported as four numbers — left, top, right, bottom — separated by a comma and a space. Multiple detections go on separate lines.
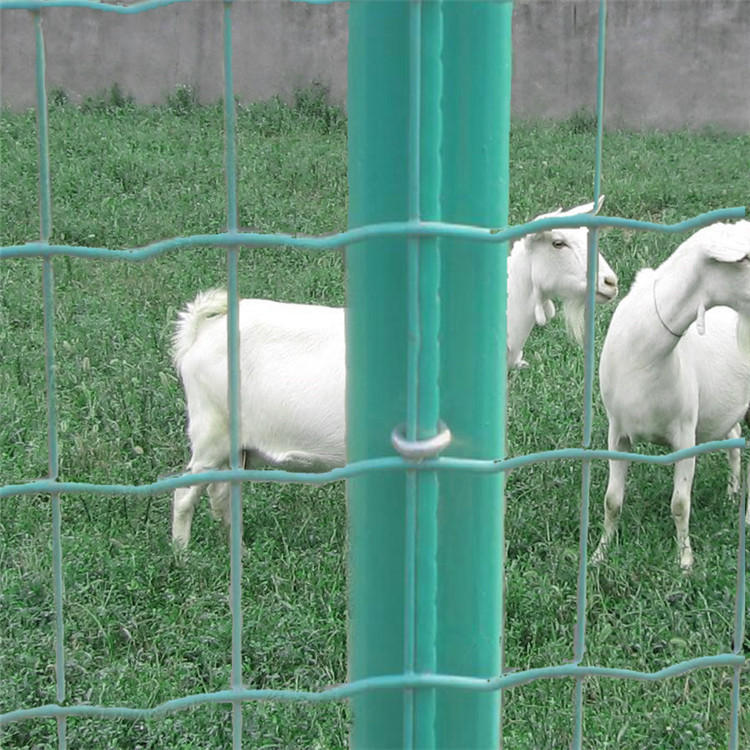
571, 0, 607, 750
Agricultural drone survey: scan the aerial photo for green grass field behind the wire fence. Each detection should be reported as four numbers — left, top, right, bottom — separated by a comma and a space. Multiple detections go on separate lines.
0, 91, 750, 750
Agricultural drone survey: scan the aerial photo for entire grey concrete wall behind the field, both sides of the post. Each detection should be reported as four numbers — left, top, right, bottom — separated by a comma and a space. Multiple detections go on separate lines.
0, 0, 750, 131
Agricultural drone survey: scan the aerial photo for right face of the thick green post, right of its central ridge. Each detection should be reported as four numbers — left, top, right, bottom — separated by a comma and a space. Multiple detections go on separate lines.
437, 2, 513, 748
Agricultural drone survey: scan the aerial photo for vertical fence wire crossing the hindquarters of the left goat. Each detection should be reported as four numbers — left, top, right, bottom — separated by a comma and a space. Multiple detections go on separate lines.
223, 0, 242, 750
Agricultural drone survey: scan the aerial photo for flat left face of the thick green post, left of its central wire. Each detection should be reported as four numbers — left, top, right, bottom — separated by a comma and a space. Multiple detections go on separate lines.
346, 0, 409, 750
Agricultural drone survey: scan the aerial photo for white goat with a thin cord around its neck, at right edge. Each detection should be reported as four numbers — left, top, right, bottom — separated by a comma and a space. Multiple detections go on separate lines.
592, 221, 750, 572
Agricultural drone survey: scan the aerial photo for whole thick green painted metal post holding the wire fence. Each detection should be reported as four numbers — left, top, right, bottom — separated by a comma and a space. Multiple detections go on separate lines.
347, 0, 511, 750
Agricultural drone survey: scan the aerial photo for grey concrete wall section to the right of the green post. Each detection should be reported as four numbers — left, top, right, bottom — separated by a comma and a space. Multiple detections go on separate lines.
513, 0, 750, 132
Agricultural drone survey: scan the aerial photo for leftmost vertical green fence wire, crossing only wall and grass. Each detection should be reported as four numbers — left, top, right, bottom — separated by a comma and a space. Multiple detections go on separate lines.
33, 10, 67, 750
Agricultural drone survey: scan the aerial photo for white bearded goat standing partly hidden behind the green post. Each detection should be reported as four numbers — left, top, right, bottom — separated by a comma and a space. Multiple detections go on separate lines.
172, 203, 617, 549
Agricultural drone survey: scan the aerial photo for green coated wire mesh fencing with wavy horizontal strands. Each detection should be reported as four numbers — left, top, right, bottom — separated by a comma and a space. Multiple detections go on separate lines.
0, 0, 745, 750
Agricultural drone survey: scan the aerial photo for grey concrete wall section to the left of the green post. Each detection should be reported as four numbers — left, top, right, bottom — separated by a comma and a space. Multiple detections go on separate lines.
0, 0, 348, 108
